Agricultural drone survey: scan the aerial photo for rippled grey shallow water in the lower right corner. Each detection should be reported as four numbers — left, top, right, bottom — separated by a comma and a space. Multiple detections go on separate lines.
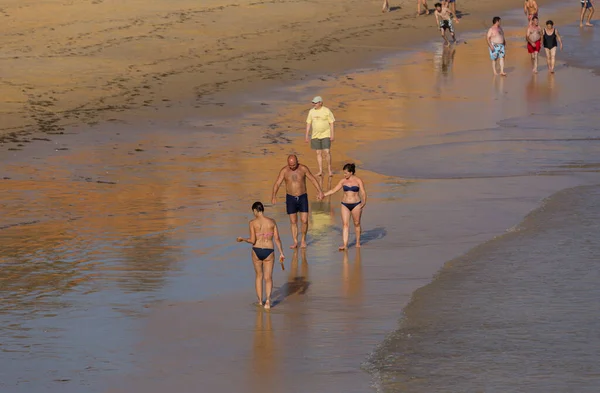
366, 186, 600, 392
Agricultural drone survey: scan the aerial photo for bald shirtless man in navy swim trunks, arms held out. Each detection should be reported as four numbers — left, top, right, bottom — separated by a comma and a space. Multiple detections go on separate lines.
271, 154, 323, 248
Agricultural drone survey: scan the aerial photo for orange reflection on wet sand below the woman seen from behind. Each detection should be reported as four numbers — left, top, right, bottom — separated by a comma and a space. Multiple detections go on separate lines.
249, 308, 279, 393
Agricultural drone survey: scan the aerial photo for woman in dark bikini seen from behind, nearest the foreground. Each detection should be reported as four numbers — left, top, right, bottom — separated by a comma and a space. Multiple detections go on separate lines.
237, 202, 285, 310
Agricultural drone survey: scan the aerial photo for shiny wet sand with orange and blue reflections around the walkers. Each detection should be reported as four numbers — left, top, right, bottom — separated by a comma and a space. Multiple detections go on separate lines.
0, 0, 598, 392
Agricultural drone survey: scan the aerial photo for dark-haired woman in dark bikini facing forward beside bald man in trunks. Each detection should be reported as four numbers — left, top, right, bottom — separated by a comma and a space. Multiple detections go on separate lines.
325, 164, 367, 251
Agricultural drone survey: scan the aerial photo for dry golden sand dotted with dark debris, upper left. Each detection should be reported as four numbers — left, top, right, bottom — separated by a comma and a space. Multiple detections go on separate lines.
0, 0, 572, 148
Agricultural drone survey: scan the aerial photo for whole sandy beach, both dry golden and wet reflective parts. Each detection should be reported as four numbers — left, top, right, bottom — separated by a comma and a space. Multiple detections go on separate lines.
0, 0, 599, 393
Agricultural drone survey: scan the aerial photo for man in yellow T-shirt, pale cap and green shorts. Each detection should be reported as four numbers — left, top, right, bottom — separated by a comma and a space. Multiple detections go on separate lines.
305, 96, 335, 176
